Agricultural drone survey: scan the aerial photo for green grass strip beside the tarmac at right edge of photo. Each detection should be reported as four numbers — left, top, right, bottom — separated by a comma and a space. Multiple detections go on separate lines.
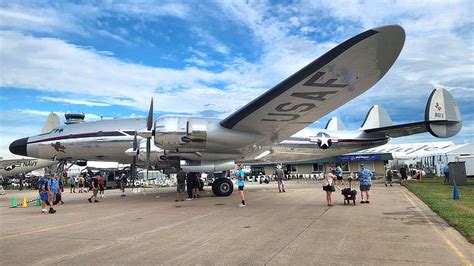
404, 176, 474, 243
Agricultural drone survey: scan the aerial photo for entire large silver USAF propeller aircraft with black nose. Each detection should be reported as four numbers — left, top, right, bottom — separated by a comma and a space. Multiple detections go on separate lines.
10, 25, 462, 196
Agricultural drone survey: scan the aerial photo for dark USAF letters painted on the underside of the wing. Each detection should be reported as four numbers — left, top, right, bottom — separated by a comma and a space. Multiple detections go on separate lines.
261, 71, 347, 122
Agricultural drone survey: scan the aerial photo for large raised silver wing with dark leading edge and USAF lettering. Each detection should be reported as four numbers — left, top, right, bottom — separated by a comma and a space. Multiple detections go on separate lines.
221, 25, 405, 142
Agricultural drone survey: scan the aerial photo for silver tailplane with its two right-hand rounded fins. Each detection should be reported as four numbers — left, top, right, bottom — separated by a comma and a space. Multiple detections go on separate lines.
361, 89, 462, 138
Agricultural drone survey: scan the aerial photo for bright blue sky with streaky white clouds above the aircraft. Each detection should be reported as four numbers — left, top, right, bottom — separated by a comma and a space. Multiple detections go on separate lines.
0, 0, 474, 157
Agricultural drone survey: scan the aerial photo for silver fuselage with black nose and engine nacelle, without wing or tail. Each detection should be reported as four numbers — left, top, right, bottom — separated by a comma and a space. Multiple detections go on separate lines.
10, 116, 388, 163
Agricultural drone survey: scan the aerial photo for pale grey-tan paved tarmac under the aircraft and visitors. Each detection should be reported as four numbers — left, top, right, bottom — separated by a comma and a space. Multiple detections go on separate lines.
0, 180, 474, 265
